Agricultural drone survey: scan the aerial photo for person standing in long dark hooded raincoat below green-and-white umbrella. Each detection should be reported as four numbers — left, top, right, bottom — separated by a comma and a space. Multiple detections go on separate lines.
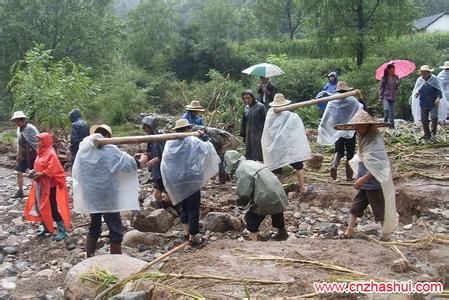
240, 90, 267, 161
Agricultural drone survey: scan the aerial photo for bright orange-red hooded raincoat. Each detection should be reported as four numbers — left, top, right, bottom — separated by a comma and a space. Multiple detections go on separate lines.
24, 132, 70, 232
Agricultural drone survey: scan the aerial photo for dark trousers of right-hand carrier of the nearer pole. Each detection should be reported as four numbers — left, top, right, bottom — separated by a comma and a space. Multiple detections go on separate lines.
176, 191, 201, 235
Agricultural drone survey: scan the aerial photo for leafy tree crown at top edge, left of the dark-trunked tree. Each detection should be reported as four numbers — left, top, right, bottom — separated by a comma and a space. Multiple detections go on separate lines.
252, 0, 307, 40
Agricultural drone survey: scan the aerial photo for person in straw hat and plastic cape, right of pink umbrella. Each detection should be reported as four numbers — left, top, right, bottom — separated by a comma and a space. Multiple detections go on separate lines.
412, 65, 447, 141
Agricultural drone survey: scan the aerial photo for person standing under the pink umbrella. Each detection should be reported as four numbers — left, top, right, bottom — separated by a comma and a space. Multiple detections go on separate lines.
379, 63, 399, 129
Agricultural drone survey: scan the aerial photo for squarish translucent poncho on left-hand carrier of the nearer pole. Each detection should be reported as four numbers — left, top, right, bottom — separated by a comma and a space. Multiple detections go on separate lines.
72, 133, 140, 214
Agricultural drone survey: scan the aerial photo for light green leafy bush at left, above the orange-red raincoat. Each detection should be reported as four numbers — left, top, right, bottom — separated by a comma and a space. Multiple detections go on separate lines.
9, 45, 98, 128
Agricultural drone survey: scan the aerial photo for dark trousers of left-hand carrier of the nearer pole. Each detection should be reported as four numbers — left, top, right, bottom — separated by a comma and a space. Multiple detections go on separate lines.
87, 212, 123, 244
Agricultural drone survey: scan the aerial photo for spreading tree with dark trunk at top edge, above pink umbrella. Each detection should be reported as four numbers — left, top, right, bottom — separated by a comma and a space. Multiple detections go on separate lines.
309, 0, 415, 66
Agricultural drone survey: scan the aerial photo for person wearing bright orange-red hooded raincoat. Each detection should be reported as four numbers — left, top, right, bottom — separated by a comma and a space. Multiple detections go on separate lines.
24, 132, 70, 241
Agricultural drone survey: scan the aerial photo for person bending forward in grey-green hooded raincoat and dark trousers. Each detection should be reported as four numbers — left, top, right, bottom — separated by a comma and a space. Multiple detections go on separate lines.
224, 150, 288, 241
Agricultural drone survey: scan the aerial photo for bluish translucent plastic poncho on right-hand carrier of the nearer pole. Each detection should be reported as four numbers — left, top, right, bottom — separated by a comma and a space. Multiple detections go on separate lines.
161, 136, 220, 205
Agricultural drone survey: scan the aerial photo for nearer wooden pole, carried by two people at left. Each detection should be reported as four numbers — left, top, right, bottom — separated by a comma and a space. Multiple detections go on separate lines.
94, 131, 200, 147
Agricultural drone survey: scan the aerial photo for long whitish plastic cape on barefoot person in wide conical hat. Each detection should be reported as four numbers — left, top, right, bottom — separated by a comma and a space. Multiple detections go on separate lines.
349, 127, 398, 233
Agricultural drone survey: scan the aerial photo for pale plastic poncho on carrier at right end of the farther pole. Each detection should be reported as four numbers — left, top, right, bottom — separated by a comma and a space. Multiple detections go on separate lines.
317, 97, 363, 145
